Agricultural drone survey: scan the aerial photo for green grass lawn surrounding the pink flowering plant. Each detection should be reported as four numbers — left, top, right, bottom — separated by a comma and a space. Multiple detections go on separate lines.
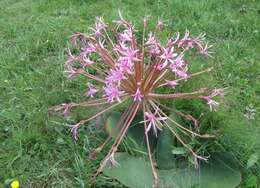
0, 0, 260, 187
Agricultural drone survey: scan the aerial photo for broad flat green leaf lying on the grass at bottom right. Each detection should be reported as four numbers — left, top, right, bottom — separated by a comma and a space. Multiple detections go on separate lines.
160, 154, 241, 188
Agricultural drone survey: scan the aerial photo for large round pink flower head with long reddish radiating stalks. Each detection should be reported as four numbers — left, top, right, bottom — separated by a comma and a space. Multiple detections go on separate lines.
51, 15, 223, 187
